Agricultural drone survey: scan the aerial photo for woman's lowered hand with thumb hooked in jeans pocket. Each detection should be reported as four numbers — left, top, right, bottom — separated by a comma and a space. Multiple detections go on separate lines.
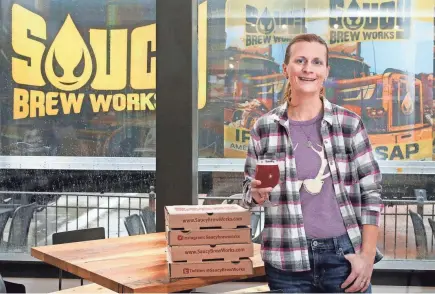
341, 254, 374, 292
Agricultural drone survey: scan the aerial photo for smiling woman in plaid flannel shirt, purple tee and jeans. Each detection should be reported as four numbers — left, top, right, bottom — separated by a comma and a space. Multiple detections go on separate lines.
244, 34, 382, 293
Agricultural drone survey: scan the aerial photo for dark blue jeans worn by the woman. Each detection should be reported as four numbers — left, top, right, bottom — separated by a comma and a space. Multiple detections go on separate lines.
265, 234, 372, 293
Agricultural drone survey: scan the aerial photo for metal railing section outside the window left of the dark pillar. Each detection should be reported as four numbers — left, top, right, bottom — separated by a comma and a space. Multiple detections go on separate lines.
0, 191, 150, 249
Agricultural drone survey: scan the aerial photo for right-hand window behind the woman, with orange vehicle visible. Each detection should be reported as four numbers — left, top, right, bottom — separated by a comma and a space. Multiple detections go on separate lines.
199, 0, 435, 264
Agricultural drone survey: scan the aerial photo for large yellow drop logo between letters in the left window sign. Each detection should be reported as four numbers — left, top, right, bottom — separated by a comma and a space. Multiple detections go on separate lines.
45, 15, 92, 91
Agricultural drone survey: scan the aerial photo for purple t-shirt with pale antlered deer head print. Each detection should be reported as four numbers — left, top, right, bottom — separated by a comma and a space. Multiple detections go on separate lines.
288, 113, 346, 238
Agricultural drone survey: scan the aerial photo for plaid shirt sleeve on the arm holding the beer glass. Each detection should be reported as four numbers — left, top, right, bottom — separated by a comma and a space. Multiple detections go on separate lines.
242, 124, 260, 208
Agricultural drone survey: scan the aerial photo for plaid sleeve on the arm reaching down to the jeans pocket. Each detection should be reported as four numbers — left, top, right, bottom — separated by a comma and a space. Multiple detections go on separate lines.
352, 120, 383, 226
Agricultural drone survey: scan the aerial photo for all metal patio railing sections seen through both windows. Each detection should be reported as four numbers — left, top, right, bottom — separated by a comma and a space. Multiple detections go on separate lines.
0, 191, 435, 259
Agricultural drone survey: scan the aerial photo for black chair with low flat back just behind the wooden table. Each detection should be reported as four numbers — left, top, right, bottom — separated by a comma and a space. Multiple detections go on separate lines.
52, 227, 106, 290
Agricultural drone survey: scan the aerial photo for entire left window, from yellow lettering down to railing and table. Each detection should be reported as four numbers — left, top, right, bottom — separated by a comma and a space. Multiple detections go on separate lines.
0, 0, 156, 254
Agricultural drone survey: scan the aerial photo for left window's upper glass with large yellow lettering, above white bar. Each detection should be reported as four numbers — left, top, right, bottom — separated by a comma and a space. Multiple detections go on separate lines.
0, 0, 156, 157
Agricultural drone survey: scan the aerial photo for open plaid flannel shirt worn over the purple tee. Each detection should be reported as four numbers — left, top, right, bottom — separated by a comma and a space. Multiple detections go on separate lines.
243, 98, 383, 271
